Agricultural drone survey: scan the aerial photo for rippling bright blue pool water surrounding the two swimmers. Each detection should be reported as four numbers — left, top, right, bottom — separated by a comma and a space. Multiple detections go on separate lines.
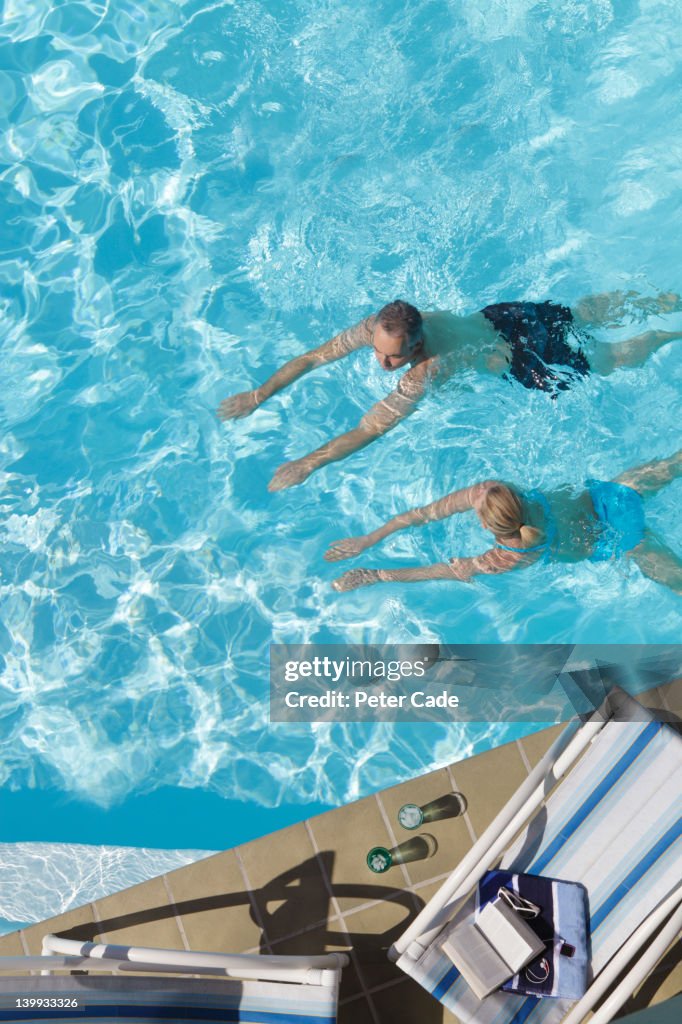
0, 0, 682, 925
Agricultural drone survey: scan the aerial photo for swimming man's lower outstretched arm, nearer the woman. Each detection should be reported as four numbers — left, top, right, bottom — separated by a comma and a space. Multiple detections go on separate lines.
268, 359, 434, 490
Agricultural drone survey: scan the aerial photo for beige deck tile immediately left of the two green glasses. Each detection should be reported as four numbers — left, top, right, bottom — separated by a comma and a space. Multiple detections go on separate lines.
310, 797, 395, 911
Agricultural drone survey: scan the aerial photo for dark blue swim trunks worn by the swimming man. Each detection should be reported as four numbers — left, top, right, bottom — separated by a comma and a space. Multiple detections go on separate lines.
481, 302, 590, 393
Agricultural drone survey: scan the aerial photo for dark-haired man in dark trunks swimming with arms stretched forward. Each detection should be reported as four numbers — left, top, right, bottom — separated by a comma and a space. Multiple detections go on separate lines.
218, 292, 682, 490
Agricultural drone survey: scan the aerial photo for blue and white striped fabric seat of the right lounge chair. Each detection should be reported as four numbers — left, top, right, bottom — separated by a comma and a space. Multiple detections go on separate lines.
399, 720, 682, 1024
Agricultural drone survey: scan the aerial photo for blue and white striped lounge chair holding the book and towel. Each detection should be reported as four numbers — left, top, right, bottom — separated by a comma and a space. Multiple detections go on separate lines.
390, 688, 682, 1024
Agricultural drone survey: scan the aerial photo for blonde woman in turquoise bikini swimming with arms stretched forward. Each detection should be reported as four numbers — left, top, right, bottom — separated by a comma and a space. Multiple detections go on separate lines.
325, 450, 682, 594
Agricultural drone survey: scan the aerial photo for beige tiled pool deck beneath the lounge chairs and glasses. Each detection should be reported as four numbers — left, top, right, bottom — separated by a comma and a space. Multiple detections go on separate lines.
0, 681, 682, 1024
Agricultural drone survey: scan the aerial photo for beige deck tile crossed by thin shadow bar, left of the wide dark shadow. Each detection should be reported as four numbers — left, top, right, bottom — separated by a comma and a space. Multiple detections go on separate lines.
166, 850, 262, 953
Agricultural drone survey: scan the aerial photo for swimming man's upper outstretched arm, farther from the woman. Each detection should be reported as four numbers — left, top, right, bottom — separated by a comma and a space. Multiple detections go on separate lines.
218, 316, 374, 420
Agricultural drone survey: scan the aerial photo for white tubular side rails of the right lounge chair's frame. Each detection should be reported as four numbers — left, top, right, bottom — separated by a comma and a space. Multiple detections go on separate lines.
388, 688, 682, 1024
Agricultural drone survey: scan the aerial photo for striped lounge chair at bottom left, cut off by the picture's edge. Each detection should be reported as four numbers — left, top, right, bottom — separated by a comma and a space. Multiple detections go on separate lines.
0, 936, 348, 1024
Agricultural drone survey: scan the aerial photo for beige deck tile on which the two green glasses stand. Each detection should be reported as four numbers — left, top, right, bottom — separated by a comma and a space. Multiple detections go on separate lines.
379, 769, 471, 885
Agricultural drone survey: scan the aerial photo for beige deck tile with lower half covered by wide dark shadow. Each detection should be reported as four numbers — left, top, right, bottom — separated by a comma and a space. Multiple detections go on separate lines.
239, 823, 329, 941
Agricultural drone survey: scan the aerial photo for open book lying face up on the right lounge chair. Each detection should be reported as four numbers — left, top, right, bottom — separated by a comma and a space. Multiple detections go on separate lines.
441, 898, 545, 999
